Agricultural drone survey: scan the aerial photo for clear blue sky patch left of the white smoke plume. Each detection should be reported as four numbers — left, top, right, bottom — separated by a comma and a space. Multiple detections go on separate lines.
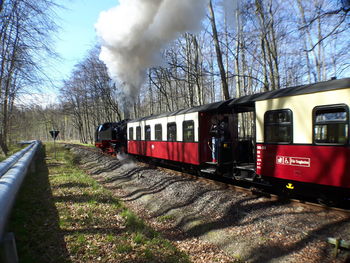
48, 0, 118, 93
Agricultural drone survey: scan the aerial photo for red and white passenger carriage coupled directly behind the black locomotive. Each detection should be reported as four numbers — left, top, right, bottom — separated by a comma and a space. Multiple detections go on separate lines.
127, 101, 232, 169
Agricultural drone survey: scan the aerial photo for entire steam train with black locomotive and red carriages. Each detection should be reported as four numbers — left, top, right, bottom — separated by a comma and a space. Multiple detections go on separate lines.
96, 78, 350, 202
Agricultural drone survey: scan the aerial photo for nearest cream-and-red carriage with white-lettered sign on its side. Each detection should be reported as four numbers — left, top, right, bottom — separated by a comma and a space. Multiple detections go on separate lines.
229, 79, 350, 201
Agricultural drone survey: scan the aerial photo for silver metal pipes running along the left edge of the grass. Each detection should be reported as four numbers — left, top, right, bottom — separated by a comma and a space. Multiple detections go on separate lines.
0, 141, 41, 263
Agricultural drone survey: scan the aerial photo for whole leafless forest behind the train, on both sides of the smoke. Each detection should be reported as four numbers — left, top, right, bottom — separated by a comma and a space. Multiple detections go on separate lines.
0, 0, 350, 153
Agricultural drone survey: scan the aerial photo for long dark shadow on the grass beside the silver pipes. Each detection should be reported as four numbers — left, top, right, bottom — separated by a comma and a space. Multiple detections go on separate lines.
9, 146, 71, 263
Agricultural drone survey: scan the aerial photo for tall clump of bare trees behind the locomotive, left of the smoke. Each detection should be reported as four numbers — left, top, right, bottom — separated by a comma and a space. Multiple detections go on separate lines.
61, 48, 123, 143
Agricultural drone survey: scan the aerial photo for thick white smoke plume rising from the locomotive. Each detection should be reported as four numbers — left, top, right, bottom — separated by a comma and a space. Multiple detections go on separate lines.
95, 0, 208, 100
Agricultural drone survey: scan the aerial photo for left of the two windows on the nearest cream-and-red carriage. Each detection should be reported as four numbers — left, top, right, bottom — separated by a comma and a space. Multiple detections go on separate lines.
264, 109, 293, 144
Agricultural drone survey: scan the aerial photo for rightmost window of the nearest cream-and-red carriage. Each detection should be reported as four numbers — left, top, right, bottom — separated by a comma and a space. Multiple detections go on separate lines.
313, 105, 349, 145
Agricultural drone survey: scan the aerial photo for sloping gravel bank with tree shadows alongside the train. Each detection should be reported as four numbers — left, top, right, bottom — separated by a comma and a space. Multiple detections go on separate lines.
68, 145, 350, 263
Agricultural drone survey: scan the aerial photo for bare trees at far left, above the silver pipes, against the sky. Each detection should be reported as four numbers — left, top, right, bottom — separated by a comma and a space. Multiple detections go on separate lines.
0, 0, 56, 154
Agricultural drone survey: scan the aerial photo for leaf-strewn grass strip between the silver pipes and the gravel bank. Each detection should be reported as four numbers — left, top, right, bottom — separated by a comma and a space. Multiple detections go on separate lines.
10, 144, 190, 263
